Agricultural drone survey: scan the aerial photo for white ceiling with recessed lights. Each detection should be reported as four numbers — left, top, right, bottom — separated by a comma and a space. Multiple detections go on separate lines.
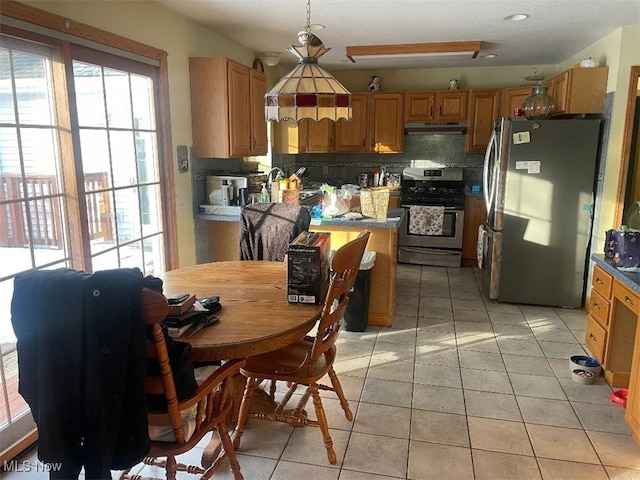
156, 0, 640, 70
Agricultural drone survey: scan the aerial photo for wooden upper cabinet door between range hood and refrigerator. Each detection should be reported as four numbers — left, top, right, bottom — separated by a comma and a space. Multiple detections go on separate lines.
465, 89, 501, 153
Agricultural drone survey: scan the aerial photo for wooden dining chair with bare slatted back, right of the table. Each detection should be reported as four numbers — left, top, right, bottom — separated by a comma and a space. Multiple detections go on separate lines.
234, 231, 370, 464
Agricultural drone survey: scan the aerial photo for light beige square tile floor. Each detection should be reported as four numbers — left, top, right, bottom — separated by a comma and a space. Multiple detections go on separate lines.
5, 265, 640, 480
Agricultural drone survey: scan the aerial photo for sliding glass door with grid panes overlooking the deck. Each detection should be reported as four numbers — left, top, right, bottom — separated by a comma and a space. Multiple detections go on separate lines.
0, 29, 166, 452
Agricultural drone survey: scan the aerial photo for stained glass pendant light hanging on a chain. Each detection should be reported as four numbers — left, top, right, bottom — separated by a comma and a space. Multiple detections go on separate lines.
264, 0, 351, 122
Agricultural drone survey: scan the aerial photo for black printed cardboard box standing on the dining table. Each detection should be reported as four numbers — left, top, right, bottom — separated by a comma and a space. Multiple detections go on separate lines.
287, 232, 331, 304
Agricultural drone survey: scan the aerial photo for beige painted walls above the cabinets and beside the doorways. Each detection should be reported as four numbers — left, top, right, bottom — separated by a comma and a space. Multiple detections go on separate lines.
16, 0, 640, 266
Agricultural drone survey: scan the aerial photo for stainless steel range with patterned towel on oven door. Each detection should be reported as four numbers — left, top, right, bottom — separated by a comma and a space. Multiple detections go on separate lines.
398, 167, 465, 267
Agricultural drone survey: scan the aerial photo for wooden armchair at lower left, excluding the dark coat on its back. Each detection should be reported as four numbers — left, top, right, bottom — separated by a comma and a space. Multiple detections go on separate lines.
120, 289, 244, 480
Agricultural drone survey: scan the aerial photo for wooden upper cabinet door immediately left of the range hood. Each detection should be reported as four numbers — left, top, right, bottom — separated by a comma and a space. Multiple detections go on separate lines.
369, 93, 404, 153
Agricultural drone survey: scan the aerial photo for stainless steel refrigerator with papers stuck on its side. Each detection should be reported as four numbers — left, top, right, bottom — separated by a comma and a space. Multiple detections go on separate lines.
479, 118, 600, 307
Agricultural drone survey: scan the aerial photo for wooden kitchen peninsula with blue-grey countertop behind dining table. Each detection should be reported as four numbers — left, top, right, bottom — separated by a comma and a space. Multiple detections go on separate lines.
196, 208, 404, 327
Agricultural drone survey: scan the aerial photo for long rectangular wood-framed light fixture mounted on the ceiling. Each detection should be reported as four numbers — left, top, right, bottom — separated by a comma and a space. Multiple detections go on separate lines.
347, 41, 482, 63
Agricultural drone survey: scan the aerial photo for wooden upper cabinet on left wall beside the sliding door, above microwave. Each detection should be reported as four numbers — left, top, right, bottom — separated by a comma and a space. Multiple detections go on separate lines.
189, 57, 267, 158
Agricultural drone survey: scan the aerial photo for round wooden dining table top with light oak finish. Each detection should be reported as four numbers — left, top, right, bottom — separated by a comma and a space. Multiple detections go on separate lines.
159, 261, 322, 362
